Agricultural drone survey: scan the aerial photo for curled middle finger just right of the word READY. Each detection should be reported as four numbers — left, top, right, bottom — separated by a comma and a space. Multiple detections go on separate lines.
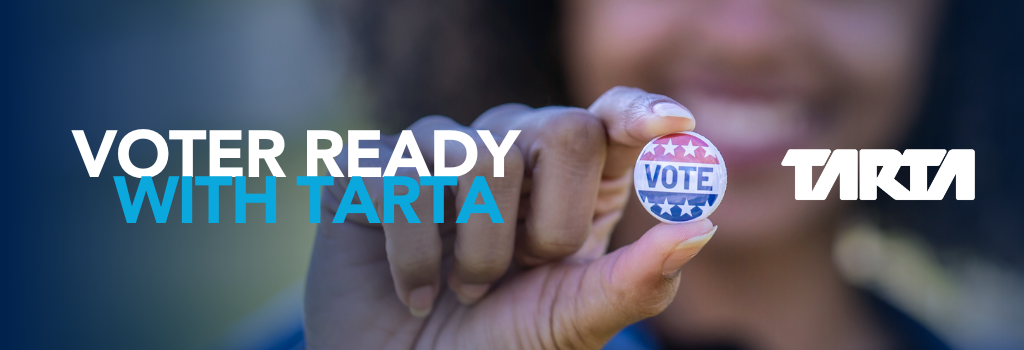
501, 107, 606, 265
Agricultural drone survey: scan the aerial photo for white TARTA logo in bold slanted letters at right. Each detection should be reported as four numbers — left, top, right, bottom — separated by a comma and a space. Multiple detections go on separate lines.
782, 149, 974, 201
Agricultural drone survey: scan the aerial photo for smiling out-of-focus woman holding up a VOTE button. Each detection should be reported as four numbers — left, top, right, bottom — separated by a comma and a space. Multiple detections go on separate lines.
305, 0, 970, 349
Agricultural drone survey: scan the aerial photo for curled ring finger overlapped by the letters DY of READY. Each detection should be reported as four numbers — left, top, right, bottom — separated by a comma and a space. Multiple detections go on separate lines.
410, 117, 523, 304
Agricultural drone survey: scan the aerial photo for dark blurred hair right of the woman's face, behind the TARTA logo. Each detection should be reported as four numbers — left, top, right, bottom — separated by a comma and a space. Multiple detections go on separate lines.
877, 1, 1024, 267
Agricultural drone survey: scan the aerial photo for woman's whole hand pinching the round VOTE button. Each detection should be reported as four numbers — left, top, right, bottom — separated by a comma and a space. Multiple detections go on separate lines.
305, 87, 714, 349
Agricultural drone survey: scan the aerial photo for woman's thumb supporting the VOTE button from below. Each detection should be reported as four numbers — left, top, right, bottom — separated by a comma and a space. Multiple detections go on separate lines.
557, 220, 718, 341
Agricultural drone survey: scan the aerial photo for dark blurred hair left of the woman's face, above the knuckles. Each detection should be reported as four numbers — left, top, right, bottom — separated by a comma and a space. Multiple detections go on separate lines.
322, 0, 567, 130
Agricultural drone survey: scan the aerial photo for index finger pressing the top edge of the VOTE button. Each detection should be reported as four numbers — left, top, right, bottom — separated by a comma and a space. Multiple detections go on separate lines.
589, 86, 696, 178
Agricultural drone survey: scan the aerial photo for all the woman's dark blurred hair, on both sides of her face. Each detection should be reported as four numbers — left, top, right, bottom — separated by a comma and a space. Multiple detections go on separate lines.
322, 0, 1024, 264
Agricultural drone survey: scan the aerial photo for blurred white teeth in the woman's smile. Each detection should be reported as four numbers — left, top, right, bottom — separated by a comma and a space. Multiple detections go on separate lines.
690, 96, 807, 147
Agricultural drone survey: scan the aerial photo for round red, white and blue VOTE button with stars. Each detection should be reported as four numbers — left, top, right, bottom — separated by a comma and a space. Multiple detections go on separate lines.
633, 131, 727, 223
